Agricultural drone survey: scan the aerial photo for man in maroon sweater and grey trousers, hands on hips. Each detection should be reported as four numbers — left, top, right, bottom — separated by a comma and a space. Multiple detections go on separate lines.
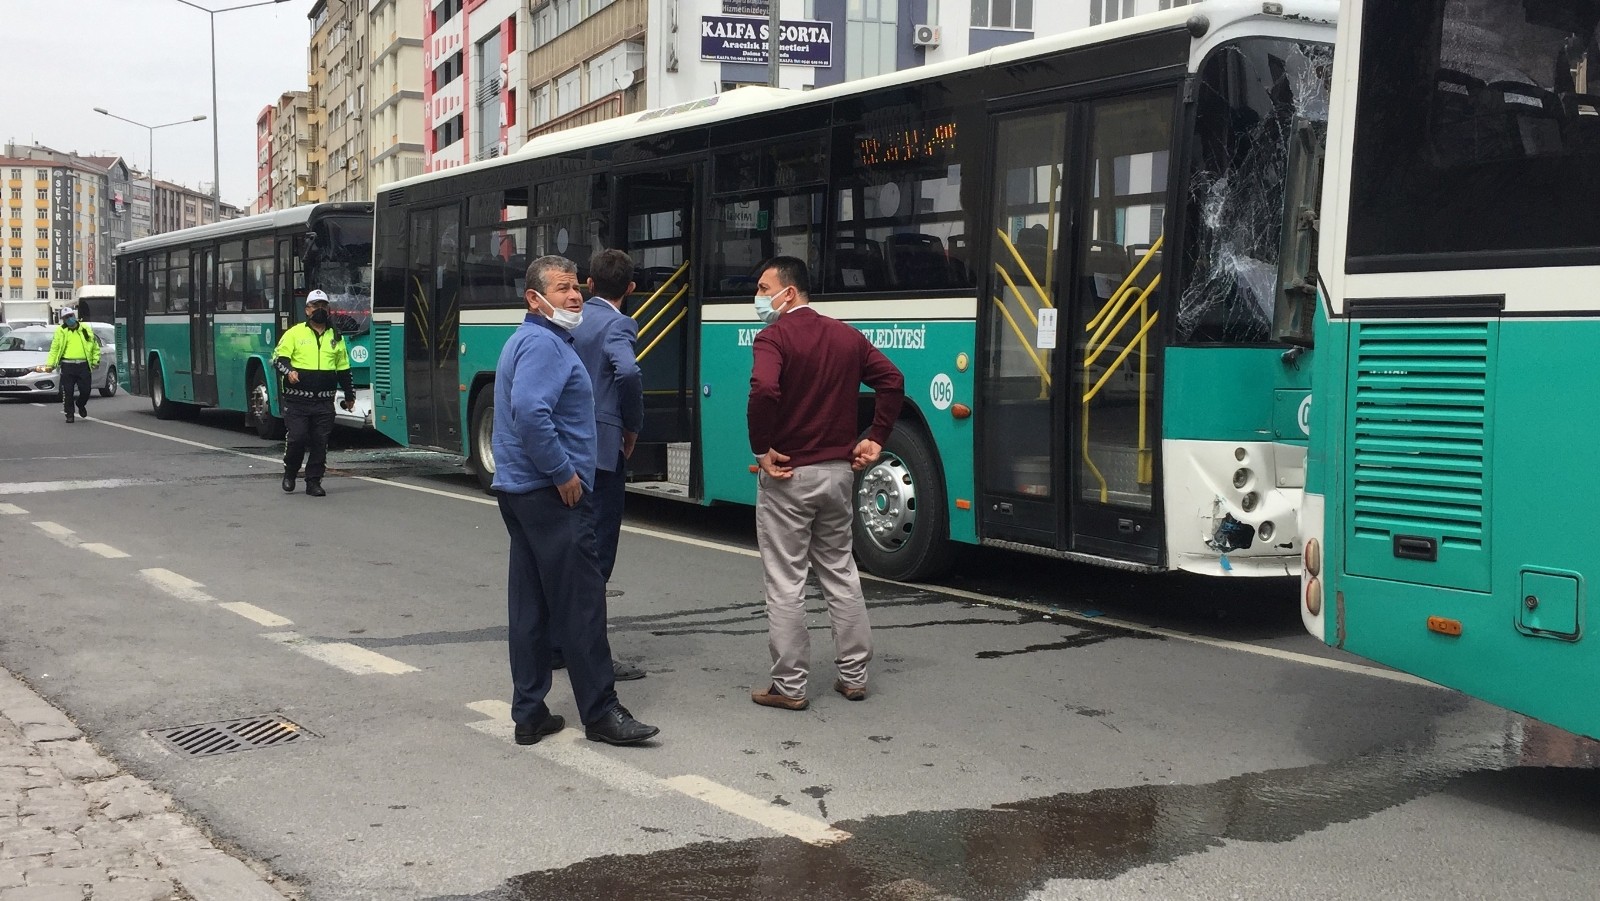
749, 256, 906, 711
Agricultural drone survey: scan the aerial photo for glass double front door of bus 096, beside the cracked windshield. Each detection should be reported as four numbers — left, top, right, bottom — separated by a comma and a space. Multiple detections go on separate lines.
979, 91, 1173, 563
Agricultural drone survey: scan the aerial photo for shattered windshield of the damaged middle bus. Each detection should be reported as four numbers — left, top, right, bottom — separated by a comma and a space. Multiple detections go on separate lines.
1178, 37, 1333, 344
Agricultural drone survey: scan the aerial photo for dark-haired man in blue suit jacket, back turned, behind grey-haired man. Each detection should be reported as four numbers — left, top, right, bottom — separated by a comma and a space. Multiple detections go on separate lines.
569, 250, 645, 682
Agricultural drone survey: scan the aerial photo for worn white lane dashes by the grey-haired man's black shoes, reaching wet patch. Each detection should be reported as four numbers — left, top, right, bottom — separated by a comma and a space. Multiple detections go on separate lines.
467, 701, 850, 845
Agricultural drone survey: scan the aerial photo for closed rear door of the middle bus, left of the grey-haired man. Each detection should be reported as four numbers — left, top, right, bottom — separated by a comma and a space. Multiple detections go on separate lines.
405, 202, 462, 453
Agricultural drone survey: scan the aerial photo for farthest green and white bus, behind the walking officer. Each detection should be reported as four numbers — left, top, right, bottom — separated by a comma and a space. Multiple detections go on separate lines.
117, 203, 373, 438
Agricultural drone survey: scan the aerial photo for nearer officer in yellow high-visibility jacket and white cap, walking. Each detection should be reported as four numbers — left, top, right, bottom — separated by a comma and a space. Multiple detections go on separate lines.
272, 290, 355, 498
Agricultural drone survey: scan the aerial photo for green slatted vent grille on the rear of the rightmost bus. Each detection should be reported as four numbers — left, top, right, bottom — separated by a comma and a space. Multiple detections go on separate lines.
1347, 322, 1498, 591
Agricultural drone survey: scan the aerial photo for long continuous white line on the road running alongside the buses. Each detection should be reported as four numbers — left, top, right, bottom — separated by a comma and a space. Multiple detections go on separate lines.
99, 419, 1438, 688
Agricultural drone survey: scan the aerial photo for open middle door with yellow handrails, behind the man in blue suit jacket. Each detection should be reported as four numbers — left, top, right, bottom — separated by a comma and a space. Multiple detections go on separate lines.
613, 165, 701, 498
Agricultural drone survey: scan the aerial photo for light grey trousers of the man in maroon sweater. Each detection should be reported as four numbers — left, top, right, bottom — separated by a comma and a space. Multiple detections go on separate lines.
755, 461, 872, 698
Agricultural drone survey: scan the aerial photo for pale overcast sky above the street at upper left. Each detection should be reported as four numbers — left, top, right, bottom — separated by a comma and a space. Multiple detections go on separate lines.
0, 0, 316, 208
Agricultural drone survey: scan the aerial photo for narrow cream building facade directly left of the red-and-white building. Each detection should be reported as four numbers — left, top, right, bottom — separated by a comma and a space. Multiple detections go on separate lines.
366, 0, 427, 194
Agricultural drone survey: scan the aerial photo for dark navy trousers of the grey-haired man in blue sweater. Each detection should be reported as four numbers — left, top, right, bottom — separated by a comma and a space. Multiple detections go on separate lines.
499, 488, 616, 723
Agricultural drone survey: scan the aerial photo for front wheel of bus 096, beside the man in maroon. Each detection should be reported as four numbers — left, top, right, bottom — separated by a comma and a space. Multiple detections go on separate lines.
854, 422, 950, 581
